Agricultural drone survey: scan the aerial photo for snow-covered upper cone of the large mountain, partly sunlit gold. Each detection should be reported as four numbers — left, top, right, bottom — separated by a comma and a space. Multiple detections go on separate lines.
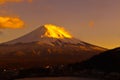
5, 24, 75, 44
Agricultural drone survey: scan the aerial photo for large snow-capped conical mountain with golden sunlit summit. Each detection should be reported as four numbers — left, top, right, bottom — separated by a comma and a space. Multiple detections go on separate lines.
0, 24, 107, 68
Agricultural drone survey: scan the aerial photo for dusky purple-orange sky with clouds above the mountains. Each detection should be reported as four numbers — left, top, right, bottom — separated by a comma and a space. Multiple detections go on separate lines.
0, 0, 120, 48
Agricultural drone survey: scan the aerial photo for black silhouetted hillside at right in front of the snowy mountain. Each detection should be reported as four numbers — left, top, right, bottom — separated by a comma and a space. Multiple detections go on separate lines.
79, 47, 120, 72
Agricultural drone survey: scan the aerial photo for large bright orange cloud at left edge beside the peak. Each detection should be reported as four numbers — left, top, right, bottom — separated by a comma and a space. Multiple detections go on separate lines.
0, 16, 24, 29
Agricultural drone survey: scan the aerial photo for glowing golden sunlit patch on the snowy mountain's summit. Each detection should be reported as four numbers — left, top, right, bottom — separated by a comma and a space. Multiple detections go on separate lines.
44, 24, 72, 39
